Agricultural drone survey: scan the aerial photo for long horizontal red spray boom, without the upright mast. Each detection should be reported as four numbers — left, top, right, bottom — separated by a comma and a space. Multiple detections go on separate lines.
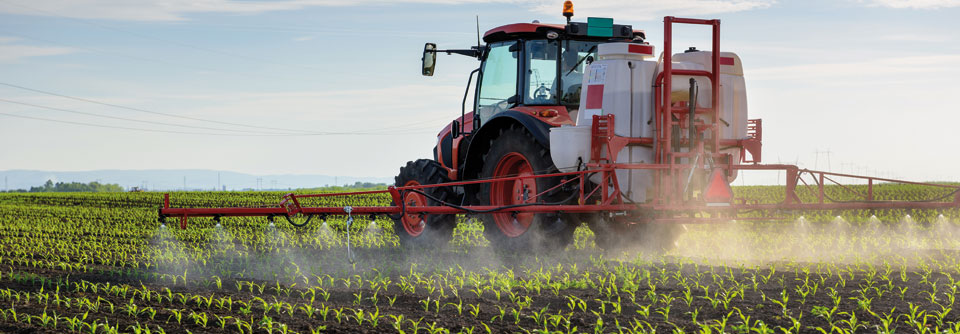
159, 164, 960, 228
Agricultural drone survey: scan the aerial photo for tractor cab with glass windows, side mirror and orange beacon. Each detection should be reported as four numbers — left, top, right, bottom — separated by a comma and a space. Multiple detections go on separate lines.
423, 9, 645, 134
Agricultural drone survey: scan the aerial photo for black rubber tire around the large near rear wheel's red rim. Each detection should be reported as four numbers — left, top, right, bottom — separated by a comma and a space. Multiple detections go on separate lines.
472, 127, 578, 255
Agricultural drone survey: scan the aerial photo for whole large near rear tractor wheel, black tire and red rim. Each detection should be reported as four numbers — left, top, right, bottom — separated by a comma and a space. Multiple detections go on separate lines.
474, 127, 576, 253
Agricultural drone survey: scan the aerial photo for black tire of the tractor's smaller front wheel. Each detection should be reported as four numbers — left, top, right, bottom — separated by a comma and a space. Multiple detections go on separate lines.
393, 159, 460, 247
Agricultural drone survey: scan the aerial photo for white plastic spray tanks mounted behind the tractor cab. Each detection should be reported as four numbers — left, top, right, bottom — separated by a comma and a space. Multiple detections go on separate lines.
550, 43, 747, 203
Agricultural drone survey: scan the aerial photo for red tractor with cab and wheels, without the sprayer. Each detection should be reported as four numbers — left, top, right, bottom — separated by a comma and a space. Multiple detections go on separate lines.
395, 1, 696, 250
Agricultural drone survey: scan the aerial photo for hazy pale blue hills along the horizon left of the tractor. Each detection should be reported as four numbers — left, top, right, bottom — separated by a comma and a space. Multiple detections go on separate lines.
0, 169, 393, 190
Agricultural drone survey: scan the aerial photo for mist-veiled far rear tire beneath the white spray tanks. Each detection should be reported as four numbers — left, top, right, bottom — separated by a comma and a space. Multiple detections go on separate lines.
588, 215, 686, 256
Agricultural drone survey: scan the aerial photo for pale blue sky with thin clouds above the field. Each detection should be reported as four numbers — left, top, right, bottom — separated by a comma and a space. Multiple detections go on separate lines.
0, 0, 960, 184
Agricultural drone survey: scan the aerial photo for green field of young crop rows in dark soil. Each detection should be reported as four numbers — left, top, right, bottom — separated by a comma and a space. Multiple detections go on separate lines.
0, 185, 960, 334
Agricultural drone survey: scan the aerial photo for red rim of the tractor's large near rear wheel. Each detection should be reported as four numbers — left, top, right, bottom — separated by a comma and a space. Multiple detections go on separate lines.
490, 152, 537, 237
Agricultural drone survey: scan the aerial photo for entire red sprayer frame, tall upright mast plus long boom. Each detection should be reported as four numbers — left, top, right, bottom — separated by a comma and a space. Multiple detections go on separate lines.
159, 16, 960, 228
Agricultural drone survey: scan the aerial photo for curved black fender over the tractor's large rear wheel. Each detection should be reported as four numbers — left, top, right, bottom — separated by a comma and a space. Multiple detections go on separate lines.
460, 110, 552, 180
